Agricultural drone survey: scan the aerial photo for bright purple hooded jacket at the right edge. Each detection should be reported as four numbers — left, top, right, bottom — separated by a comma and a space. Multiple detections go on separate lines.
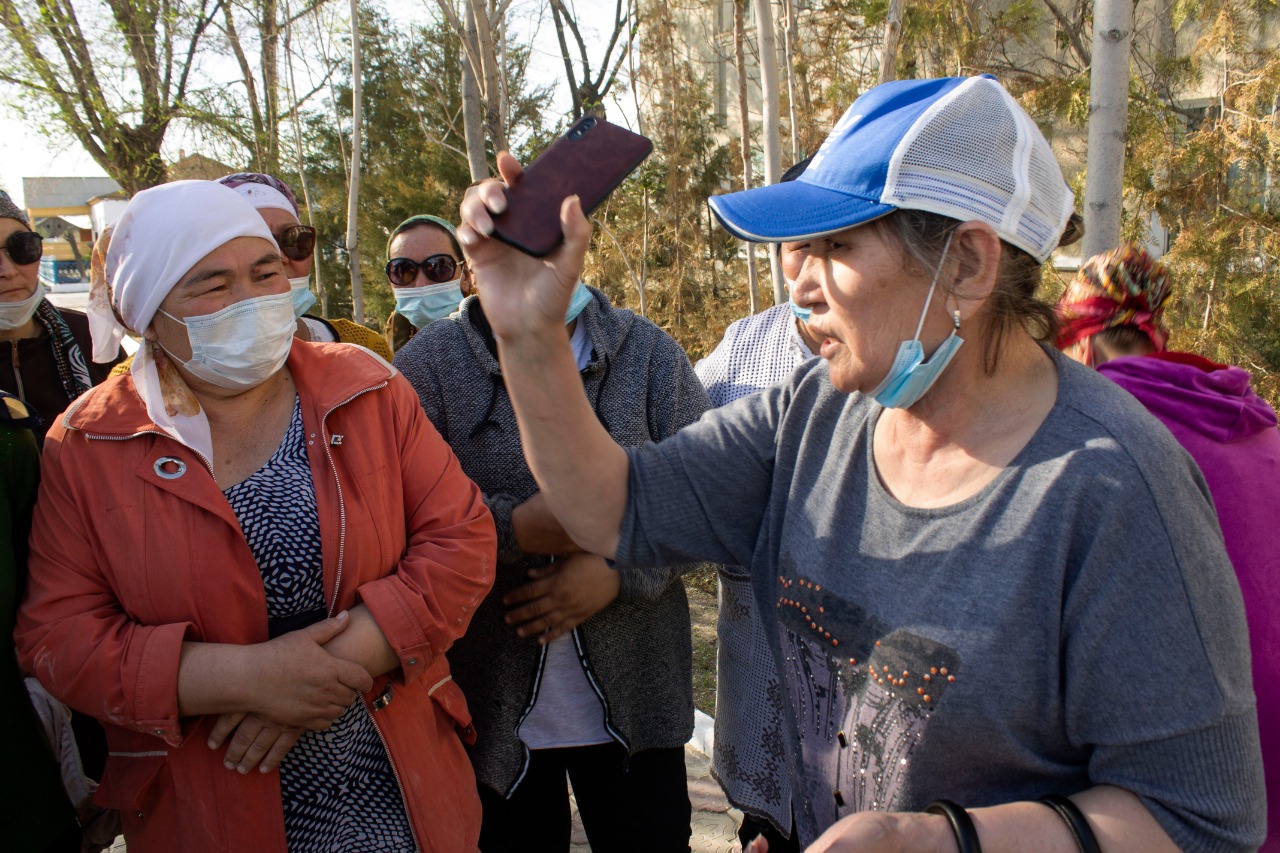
1098, 352, 1280, 853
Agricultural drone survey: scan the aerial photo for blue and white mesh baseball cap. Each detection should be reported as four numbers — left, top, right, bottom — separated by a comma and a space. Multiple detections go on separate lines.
709, 76, 1075, 263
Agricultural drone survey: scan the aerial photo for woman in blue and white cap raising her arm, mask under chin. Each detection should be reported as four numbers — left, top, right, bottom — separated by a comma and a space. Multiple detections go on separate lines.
458, 77, 1266, 853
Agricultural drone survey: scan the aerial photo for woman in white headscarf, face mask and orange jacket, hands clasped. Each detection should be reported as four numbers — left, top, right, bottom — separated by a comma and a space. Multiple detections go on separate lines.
17, 181, 495, 852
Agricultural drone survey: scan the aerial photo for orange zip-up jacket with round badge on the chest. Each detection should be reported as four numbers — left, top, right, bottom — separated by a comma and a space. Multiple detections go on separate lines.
17, 341, 497, 853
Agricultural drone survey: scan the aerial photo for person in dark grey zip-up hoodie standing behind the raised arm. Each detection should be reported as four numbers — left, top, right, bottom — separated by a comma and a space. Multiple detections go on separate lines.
396, 283, 709, 853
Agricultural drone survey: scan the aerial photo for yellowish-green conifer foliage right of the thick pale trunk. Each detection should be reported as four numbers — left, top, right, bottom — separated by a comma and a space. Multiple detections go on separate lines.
1125, 0, 1280, 406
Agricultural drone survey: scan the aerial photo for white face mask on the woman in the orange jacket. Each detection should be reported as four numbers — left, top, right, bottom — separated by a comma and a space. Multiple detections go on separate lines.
157, 293, 297, 391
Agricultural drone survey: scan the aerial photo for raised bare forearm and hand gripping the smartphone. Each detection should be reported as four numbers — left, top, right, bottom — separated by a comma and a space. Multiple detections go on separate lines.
458, 154, 627, 557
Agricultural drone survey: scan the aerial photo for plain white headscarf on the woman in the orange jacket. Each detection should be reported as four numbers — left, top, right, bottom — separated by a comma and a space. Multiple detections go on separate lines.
87, 181, 275, 465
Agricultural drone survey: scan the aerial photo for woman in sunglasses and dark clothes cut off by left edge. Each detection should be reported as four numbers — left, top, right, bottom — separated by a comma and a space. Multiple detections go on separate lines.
0, 192, 124, 443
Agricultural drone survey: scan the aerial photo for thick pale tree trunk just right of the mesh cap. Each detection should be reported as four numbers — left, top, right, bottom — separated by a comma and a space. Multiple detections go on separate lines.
1082, 0, 1133, 259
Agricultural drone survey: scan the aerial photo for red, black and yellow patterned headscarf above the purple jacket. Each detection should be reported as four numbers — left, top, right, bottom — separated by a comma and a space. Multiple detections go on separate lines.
1056, 243, 1169, 351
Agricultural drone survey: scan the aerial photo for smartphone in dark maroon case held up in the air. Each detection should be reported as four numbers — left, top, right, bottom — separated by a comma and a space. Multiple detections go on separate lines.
493, 115, 653, 257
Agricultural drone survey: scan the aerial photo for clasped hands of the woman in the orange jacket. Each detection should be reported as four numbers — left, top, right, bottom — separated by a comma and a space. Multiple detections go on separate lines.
209, 611, 374, 774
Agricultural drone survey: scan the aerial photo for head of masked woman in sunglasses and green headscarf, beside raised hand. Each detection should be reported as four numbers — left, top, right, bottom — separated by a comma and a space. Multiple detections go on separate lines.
385, 214, 474, 352
